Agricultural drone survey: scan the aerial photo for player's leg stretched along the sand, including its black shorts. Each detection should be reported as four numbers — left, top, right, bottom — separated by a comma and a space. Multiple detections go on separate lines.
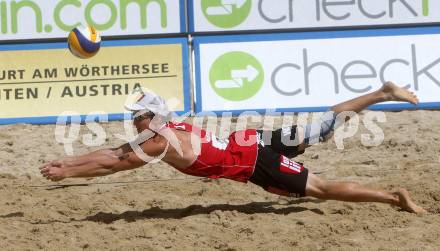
249, 146, 426, 213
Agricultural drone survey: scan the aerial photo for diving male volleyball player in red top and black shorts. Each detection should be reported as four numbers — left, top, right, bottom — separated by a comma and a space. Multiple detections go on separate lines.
40, 82, 425, 213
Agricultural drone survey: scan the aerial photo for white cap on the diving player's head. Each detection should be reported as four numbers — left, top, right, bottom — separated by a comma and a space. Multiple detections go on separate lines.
125, 92, 171, 120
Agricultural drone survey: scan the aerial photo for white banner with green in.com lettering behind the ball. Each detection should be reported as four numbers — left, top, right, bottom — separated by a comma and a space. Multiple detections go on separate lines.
0, 0, 186, 40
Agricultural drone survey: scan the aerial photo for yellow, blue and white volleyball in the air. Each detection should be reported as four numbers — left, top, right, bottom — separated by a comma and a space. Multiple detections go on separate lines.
67, 26, 101, 58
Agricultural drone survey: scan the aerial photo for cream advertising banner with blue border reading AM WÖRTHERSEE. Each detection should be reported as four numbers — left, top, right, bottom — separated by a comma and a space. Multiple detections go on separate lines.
0, 38, 190, 124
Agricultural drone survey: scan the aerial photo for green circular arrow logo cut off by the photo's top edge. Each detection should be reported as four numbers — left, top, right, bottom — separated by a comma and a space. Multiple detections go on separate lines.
202, 0, 252, 28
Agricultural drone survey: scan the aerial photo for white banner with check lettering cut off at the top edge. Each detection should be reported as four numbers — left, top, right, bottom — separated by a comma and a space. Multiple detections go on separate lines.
189, 0, 440, 32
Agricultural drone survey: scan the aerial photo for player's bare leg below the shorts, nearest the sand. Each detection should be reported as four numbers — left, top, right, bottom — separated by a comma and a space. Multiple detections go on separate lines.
306, 173, 426, 213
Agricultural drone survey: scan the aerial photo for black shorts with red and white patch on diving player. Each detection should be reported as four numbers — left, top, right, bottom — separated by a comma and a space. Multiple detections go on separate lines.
249, 127, 309, 197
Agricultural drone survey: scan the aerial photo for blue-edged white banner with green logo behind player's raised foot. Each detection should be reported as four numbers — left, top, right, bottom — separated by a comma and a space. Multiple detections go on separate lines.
195, 27, 440, 112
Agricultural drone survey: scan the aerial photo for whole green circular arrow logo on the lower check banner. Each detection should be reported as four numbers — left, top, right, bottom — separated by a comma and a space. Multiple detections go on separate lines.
209, 51, 264, 101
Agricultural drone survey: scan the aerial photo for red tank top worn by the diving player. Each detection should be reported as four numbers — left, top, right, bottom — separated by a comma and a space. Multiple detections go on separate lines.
167, 123, 258, 182
